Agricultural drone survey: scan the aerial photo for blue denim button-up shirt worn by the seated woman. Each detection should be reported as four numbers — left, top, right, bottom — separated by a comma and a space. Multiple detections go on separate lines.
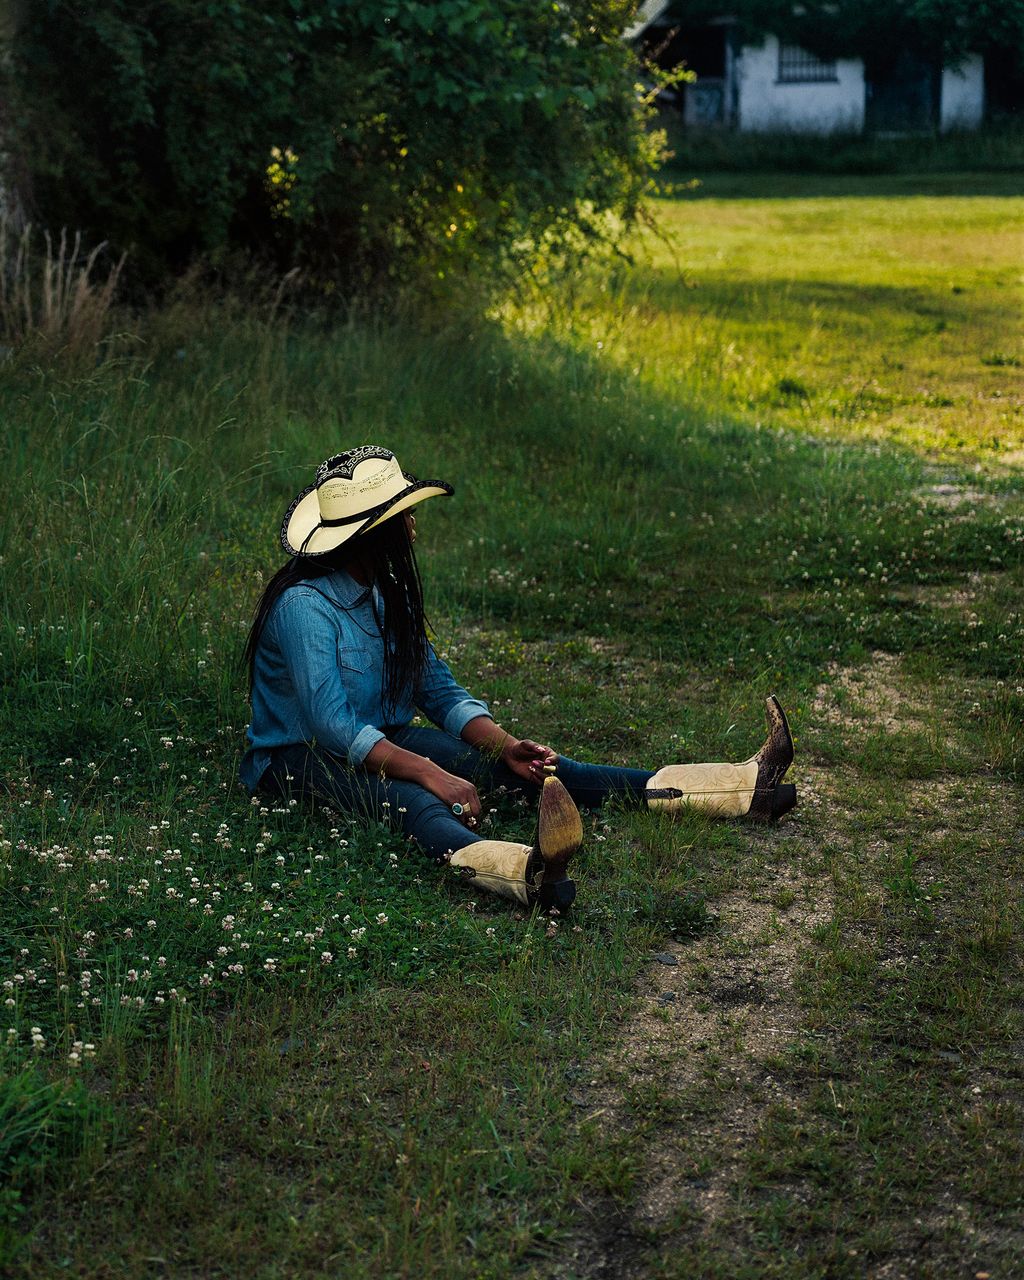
239, 570, 490, 794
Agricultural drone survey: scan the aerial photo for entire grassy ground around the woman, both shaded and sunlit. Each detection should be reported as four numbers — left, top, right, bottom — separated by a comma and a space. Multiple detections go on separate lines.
0, 178, 1024, 1280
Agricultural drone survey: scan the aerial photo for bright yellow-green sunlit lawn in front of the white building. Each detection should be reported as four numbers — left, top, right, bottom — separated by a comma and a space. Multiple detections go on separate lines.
519, 174, 1024, 458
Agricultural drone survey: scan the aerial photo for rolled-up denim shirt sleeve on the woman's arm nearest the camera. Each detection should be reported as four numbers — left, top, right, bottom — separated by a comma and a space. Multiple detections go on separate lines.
274, 590, 384, 765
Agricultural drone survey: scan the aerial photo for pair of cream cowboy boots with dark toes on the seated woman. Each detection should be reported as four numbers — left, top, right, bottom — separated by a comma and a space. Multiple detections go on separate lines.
449, 694, 796, 910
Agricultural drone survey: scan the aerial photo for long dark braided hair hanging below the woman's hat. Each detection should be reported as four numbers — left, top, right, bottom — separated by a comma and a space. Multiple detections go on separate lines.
242, 516, 429, 718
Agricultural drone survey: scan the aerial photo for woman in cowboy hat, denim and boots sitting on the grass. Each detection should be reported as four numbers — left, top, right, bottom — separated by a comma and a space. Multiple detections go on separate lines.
241, 445, 796, 909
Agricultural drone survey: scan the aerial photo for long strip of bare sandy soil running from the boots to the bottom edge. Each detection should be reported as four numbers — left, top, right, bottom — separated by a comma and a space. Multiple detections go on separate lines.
555, 769, 833, 1280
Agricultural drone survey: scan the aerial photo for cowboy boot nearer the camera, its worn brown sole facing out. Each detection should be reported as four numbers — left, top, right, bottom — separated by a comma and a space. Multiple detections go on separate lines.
448, 778, 584, 910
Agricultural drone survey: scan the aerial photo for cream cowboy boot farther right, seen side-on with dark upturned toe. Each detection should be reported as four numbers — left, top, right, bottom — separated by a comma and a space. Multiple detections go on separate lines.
645, 694, 796, 822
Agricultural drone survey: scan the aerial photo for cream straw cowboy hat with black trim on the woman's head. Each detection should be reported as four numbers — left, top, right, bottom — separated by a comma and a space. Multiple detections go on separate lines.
280, 444, 454, 556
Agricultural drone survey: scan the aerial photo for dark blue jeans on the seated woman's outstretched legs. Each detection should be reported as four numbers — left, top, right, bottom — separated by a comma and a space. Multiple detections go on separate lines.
257, 726, 653, 859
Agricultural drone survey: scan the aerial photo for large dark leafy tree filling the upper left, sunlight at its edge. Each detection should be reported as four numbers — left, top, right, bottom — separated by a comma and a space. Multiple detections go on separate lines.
4, 0, 658, 284
